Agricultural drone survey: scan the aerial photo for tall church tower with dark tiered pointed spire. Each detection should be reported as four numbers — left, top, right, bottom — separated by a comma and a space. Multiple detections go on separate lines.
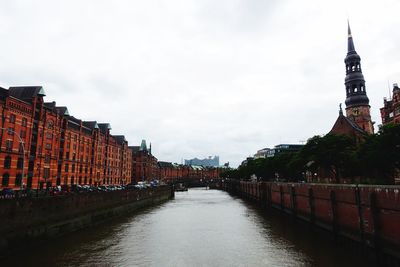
344, 21, 374, 134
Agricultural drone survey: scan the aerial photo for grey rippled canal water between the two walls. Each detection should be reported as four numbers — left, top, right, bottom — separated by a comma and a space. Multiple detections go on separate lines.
0, 188, 371, 267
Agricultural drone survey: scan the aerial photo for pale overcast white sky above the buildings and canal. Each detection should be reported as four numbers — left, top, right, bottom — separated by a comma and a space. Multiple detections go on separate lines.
0, 0, 400, 166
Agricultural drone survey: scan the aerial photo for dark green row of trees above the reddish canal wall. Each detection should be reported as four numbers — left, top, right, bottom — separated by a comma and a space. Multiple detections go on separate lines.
221, 124, 400, 184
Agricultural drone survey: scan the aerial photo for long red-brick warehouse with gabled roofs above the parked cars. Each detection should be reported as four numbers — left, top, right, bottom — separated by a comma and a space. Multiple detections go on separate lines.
0, 86, 132, 189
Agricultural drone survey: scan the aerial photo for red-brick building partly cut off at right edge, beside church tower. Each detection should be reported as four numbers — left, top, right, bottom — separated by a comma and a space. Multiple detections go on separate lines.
381, 83, 400, 125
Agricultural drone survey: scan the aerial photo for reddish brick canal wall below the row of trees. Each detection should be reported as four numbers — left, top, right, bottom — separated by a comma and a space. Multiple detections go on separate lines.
224, 181, 400, 260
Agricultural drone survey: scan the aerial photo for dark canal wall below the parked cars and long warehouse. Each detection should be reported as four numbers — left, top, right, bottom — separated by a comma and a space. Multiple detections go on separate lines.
0, 186, 173, 255
